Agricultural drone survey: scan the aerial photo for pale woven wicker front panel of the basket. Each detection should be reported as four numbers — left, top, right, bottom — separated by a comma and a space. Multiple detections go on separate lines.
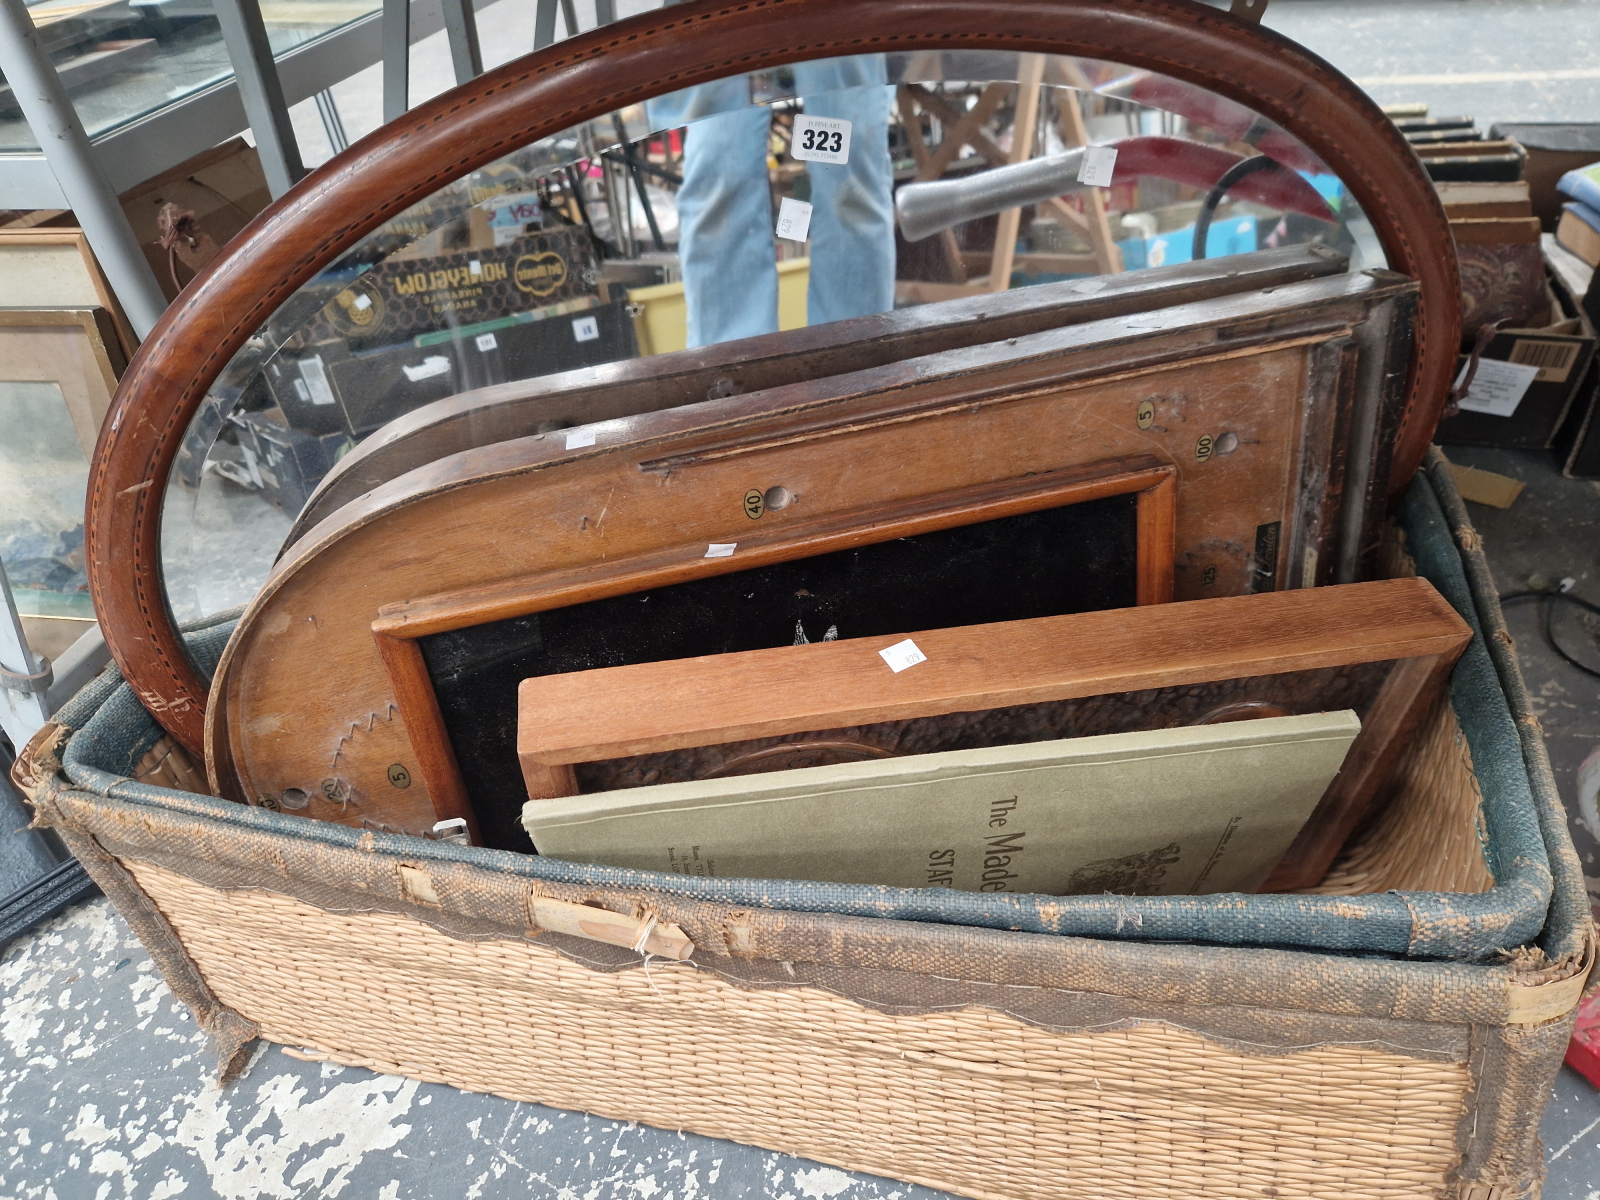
128, 862, 1470, 1200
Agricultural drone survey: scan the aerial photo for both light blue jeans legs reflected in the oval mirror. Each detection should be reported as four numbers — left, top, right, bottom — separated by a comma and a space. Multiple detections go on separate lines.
650, 54, 894, 346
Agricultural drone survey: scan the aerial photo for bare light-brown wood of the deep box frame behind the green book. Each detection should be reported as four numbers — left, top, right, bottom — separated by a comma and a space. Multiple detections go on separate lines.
517, 578, 1472, 891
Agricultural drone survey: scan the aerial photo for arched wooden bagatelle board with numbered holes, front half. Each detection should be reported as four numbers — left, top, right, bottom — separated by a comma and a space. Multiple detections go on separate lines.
206, 272, 1413, 832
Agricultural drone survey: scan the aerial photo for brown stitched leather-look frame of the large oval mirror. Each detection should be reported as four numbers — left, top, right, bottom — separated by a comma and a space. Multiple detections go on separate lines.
85, 0, 1461, 754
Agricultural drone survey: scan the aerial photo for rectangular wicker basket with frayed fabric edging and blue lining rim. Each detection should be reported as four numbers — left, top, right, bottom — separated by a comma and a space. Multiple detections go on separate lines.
21, 461, 1594, 1200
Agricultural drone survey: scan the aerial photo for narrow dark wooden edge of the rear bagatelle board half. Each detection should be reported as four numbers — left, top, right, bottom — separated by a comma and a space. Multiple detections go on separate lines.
283, 245, 1347, 549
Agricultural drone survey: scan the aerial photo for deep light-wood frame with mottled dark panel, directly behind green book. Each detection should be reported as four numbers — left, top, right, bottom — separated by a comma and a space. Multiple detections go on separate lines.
517, 579, 1472, 888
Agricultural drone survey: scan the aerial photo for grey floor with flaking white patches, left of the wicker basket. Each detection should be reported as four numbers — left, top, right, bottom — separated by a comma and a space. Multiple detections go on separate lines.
0, 899, 941, 1200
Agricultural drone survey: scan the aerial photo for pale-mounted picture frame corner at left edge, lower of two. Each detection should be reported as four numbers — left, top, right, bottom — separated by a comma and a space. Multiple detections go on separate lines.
0, 307, 126, 462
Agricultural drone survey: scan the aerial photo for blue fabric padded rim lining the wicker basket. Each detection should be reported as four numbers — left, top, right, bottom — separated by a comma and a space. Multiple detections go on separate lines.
58, 454, 1565, 962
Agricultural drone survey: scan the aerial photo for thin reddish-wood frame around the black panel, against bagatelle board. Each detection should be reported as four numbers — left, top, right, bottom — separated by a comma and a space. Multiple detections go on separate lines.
373, 459, 1178, 843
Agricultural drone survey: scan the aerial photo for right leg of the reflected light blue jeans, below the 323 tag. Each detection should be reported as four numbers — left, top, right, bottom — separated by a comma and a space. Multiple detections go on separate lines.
795, 54, 894, 325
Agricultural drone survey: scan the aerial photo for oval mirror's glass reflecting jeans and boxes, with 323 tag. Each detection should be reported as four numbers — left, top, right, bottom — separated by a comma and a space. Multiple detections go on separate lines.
162, 51, 1384, 621
